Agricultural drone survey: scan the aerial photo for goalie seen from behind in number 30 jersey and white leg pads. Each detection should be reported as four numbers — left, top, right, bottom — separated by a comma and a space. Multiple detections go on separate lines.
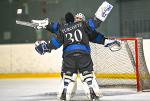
35, 0, 116, 100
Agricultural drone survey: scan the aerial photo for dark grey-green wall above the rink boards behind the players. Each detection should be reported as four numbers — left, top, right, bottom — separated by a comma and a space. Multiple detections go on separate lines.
0, 0, 150, 44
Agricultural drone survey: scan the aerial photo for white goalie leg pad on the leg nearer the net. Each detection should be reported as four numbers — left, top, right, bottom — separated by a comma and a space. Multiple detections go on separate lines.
80, 71, 102, 99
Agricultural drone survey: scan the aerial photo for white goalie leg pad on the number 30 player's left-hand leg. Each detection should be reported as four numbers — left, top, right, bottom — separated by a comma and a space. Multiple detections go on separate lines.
57, 73, 77, 101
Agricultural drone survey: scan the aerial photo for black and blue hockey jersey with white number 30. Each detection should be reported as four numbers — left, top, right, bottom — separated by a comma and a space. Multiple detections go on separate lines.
46, 20, 105, 55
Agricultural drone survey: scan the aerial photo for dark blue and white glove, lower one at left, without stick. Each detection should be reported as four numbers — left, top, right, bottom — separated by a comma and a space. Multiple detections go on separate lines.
35, 41, 51, 55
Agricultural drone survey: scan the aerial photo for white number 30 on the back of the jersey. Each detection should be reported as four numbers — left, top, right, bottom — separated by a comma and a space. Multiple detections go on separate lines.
66, 29, 82, 43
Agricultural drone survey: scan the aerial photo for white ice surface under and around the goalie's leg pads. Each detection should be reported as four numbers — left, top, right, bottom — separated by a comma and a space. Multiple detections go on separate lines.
0, 78, 150, 101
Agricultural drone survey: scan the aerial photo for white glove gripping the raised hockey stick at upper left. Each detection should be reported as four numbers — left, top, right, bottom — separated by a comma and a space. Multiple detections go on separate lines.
31, 18, 49, 30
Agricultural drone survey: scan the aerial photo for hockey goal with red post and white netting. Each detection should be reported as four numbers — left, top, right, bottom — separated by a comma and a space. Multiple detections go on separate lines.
91, 38, 150, 91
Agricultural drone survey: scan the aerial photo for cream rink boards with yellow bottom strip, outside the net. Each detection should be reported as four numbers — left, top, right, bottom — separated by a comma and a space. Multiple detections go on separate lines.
0, 39, 150, 78
